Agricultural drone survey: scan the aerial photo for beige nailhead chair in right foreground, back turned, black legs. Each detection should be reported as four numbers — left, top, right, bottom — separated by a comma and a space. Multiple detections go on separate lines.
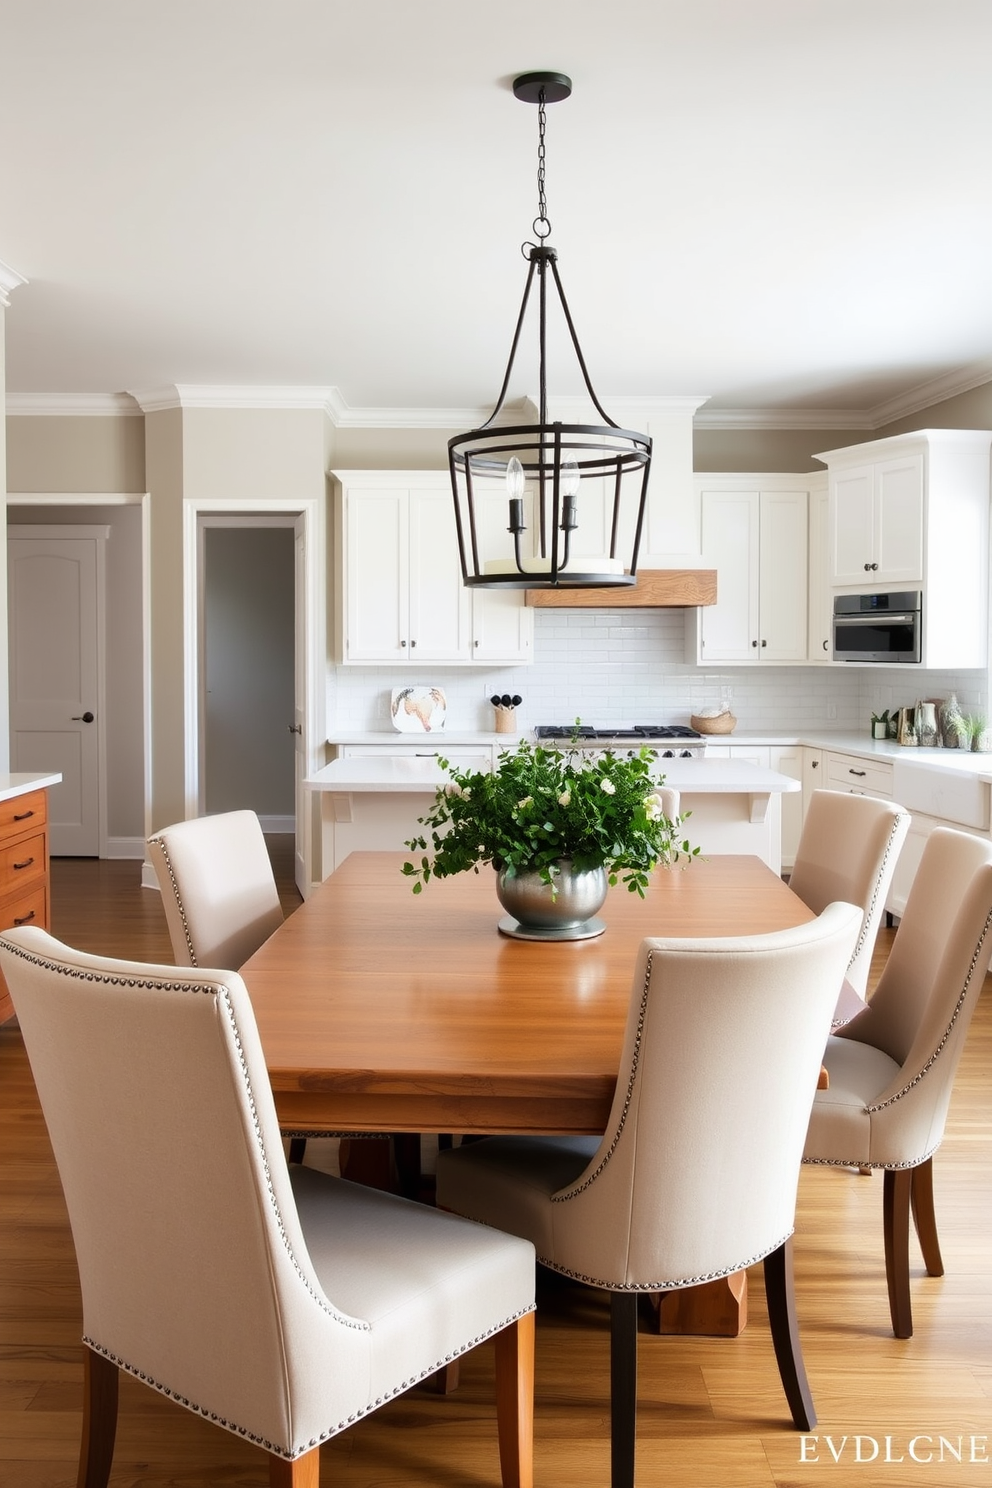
437, 905, 861, 1488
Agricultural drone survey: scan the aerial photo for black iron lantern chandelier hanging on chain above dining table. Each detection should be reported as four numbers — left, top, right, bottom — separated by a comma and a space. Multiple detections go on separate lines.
448, 73, 651, 589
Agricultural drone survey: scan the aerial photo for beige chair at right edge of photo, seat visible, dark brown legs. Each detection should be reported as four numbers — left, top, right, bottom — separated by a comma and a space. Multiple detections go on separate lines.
805, 827, 992, 1338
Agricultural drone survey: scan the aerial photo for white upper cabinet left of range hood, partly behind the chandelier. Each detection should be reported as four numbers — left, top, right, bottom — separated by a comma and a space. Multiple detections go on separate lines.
333, 470, 534, 667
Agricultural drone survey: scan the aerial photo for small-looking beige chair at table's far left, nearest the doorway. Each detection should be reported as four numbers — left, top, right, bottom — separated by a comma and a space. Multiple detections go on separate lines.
147, 811, 283, 972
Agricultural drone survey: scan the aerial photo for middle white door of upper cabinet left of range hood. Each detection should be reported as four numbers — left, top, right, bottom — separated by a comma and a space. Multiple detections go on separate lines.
409, 487, 471, 664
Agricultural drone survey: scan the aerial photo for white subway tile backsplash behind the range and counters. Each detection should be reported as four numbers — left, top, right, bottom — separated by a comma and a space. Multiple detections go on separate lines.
327, 609, 989, 734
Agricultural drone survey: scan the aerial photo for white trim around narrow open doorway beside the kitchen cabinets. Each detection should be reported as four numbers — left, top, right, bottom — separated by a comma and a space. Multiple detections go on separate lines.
183, 497, 326, 893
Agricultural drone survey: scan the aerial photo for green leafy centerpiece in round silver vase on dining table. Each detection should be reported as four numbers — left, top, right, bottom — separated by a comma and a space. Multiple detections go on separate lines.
403, 743, 699, 940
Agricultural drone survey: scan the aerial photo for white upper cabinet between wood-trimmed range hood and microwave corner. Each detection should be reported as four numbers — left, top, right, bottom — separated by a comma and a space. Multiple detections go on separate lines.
686, 476, 809, 665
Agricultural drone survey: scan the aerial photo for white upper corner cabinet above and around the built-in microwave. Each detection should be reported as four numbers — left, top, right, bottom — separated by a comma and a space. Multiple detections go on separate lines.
817, 429, 992, 668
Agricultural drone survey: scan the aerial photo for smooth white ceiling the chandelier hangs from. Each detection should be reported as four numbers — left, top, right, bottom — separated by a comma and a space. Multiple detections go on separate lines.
0, 0, 992, 426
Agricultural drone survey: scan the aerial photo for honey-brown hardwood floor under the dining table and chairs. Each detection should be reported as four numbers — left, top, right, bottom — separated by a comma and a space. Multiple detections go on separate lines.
0, 860, 992, 1488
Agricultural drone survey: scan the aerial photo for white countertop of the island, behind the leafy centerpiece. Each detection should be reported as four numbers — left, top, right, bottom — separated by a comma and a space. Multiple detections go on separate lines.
305, 761, 802, 796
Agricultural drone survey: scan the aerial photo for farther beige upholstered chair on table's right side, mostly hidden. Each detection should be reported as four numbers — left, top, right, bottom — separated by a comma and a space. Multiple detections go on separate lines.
788, 790, 910, 997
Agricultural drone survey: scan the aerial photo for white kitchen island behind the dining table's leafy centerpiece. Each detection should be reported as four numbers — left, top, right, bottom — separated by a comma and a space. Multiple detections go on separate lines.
305, 755, 802, 878
